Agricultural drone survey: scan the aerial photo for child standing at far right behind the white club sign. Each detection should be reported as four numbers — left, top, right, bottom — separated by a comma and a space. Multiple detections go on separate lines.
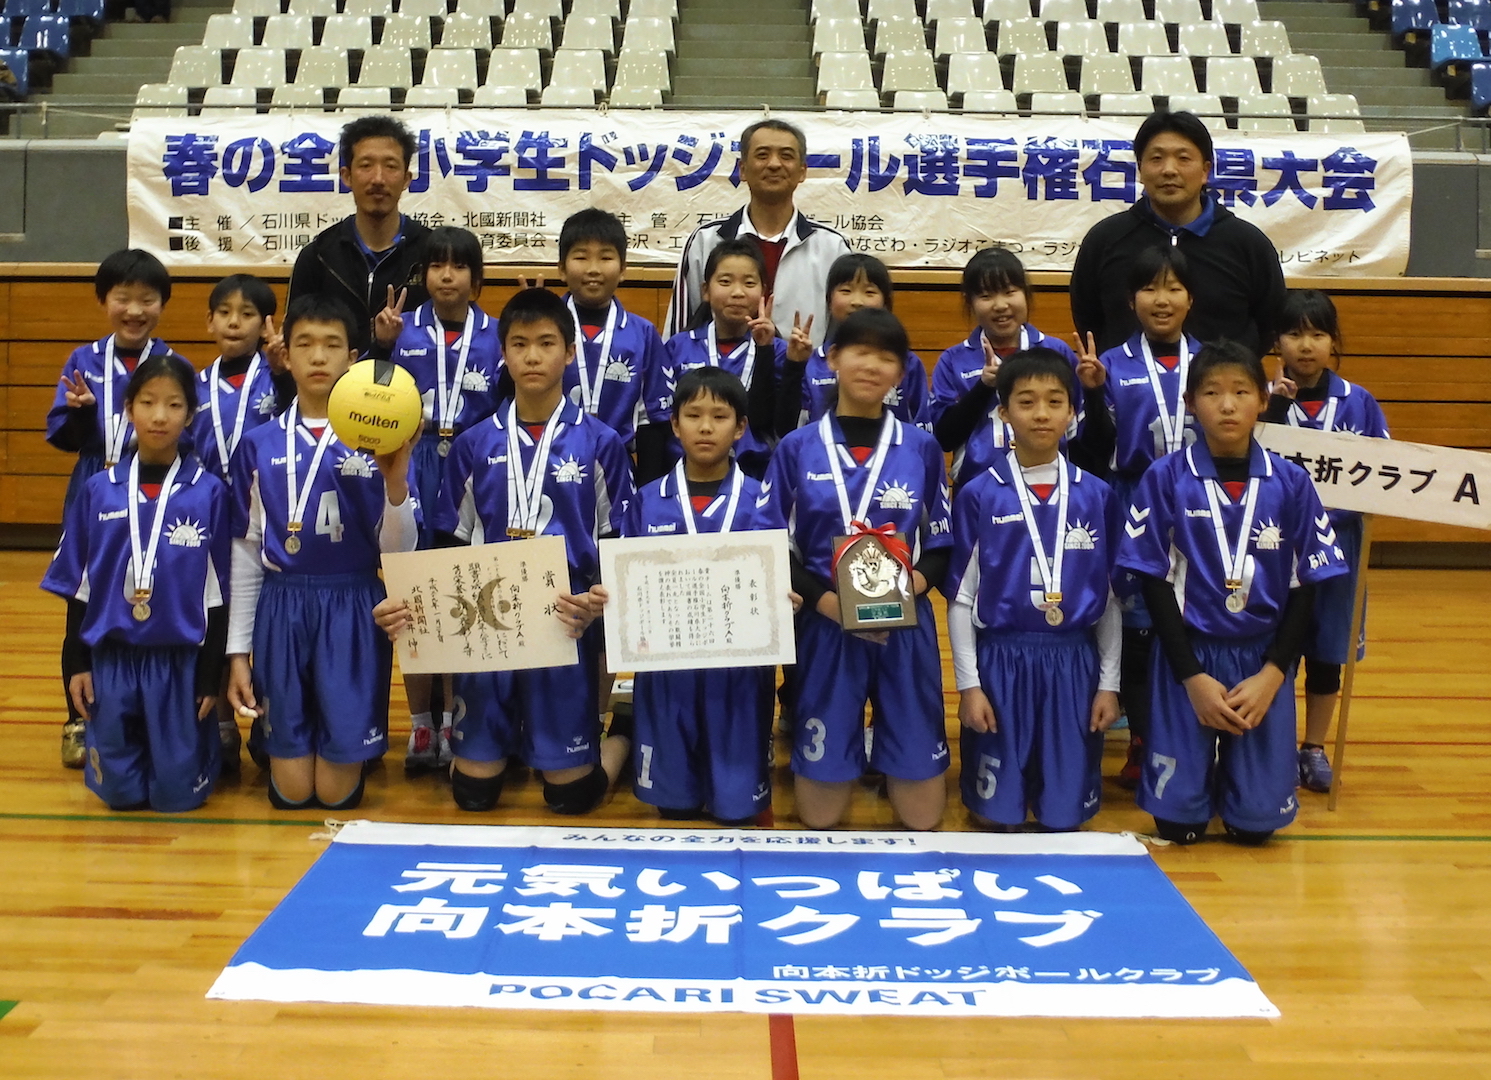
1267, 289, 1388, 792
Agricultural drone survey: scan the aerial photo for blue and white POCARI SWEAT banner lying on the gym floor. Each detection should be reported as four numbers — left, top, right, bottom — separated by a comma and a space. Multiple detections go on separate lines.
209, 822, 1278, 1017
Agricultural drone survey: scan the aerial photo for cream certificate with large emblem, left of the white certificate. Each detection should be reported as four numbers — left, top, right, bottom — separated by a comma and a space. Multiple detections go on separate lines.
383, 536, 579, 674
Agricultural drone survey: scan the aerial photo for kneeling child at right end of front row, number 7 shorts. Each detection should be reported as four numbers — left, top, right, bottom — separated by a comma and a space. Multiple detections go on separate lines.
1118, 342, 1346, 844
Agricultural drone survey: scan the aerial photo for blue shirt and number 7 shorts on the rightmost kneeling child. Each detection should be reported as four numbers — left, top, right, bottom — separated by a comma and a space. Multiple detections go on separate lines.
1118, 439, 1346, 832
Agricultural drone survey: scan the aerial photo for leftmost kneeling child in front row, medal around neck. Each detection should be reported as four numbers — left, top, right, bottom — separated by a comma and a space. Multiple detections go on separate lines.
42, 355, 231, 811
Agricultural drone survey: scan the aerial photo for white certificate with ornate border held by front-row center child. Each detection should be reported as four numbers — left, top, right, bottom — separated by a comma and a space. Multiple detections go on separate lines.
601, 530, 798, 671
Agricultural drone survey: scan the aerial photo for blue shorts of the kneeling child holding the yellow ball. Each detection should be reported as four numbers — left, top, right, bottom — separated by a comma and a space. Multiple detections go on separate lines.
253, 573, 394, 765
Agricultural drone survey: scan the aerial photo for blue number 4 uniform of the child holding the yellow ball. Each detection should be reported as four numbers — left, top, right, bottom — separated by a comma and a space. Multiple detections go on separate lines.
228, 406, 417, 764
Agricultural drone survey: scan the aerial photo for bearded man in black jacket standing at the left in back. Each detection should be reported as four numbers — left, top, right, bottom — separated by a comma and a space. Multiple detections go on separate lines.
289, 116, 429, 357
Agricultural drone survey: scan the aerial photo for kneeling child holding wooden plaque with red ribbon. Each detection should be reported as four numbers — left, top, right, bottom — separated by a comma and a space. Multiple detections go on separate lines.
760, 307, 953, 829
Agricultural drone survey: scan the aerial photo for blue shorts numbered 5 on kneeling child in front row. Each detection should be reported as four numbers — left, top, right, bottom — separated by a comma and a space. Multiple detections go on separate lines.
960, 630, 1103, 829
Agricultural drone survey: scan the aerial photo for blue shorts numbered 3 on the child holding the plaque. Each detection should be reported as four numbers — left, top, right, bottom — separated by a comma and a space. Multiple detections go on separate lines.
792, 597, 948, 783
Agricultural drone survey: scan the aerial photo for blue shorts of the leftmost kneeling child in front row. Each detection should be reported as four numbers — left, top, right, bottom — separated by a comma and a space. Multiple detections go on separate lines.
83, 641, 221, 813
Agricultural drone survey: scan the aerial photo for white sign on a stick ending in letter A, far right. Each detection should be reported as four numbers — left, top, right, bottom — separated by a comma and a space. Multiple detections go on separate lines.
1252, 424, 1491, 528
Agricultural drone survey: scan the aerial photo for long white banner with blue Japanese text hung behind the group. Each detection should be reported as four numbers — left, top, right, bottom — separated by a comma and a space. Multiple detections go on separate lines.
128, 109, 1413, 276
